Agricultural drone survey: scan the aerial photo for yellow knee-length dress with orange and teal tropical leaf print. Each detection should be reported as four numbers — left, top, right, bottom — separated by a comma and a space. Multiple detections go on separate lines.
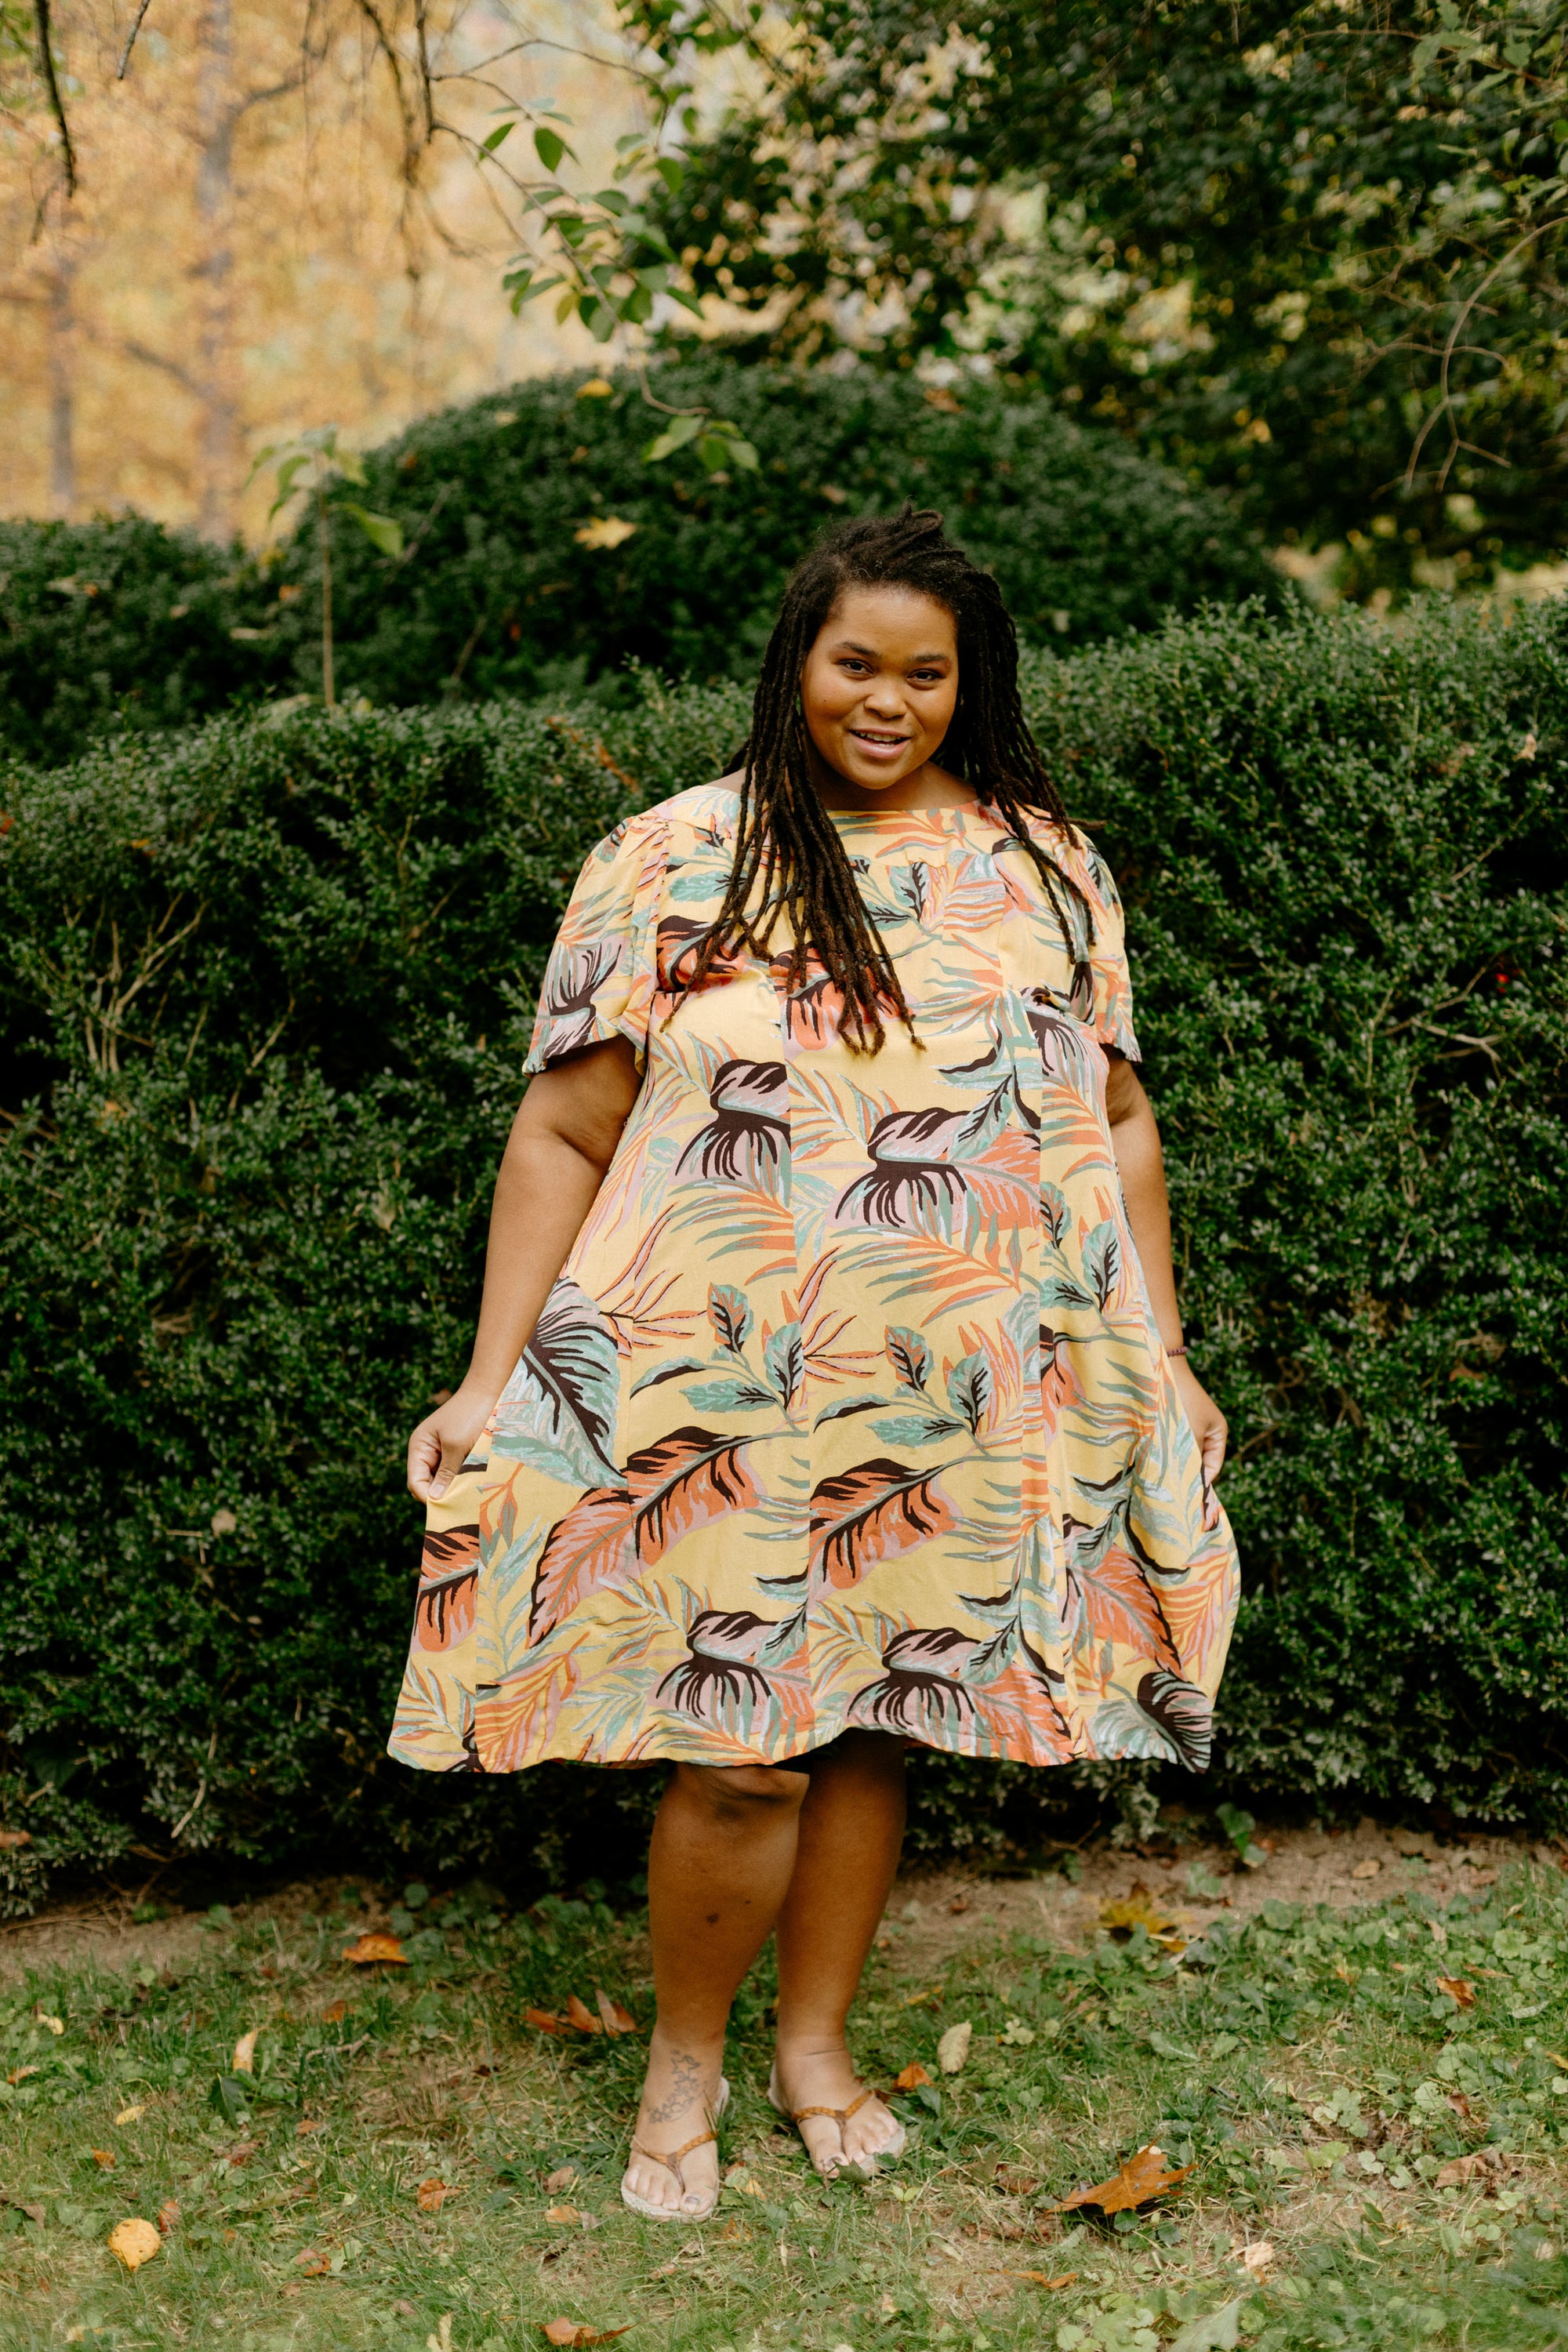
390, 786, 1236, 1773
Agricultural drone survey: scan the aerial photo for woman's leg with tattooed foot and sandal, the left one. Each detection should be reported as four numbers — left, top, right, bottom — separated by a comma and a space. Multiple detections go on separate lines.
626, 1764, 808, 2211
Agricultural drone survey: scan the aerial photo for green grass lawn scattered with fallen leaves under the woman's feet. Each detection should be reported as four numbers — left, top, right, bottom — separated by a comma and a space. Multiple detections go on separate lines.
0, 1863, 1568, 2352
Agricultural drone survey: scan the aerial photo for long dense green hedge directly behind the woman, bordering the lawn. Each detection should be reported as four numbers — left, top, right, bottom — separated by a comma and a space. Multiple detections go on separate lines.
0, 607, 1568, 1900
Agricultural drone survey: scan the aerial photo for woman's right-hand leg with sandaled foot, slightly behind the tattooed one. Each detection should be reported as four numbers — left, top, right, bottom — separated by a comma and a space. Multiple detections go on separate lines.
779, 1731, 905, 2166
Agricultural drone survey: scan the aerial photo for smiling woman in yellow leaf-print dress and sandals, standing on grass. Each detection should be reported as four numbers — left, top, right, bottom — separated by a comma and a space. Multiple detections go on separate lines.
390, 513, 1236, 2220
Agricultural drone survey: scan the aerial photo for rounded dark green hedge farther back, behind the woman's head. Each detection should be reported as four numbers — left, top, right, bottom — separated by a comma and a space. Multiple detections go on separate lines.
0, 358, 1281, 764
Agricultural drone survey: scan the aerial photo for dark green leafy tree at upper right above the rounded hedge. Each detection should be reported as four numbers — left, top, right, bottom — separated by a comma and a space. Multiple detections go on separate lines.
606, 0, 1568, 595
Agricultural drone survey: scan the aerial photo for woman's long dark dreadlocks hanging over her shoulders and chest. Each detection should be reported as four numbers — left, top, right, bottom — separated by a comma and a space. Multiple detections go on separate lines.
691, 506, 1093, 1054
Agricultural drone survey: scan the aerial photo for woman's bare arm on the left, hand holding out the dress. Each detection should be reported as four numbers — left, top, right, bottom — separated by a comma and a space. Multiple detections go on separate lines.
409, 1037, 640, 1503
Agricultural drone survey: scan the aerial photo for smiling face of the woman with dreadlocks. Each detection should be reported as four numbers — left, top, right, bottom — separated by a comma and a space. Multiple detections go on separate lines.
799, 588, 959, 793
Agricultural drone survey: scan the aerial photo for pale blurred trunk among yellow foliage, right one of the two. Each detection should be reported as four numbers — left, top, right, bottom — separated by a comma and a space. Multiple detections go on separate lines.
195, 0, 240, 539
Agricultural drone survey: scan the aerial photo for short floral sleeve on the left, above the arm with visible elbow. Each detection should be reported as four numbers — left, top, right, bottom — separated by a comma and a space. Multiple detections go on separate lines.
522, 811, 670, 1077
